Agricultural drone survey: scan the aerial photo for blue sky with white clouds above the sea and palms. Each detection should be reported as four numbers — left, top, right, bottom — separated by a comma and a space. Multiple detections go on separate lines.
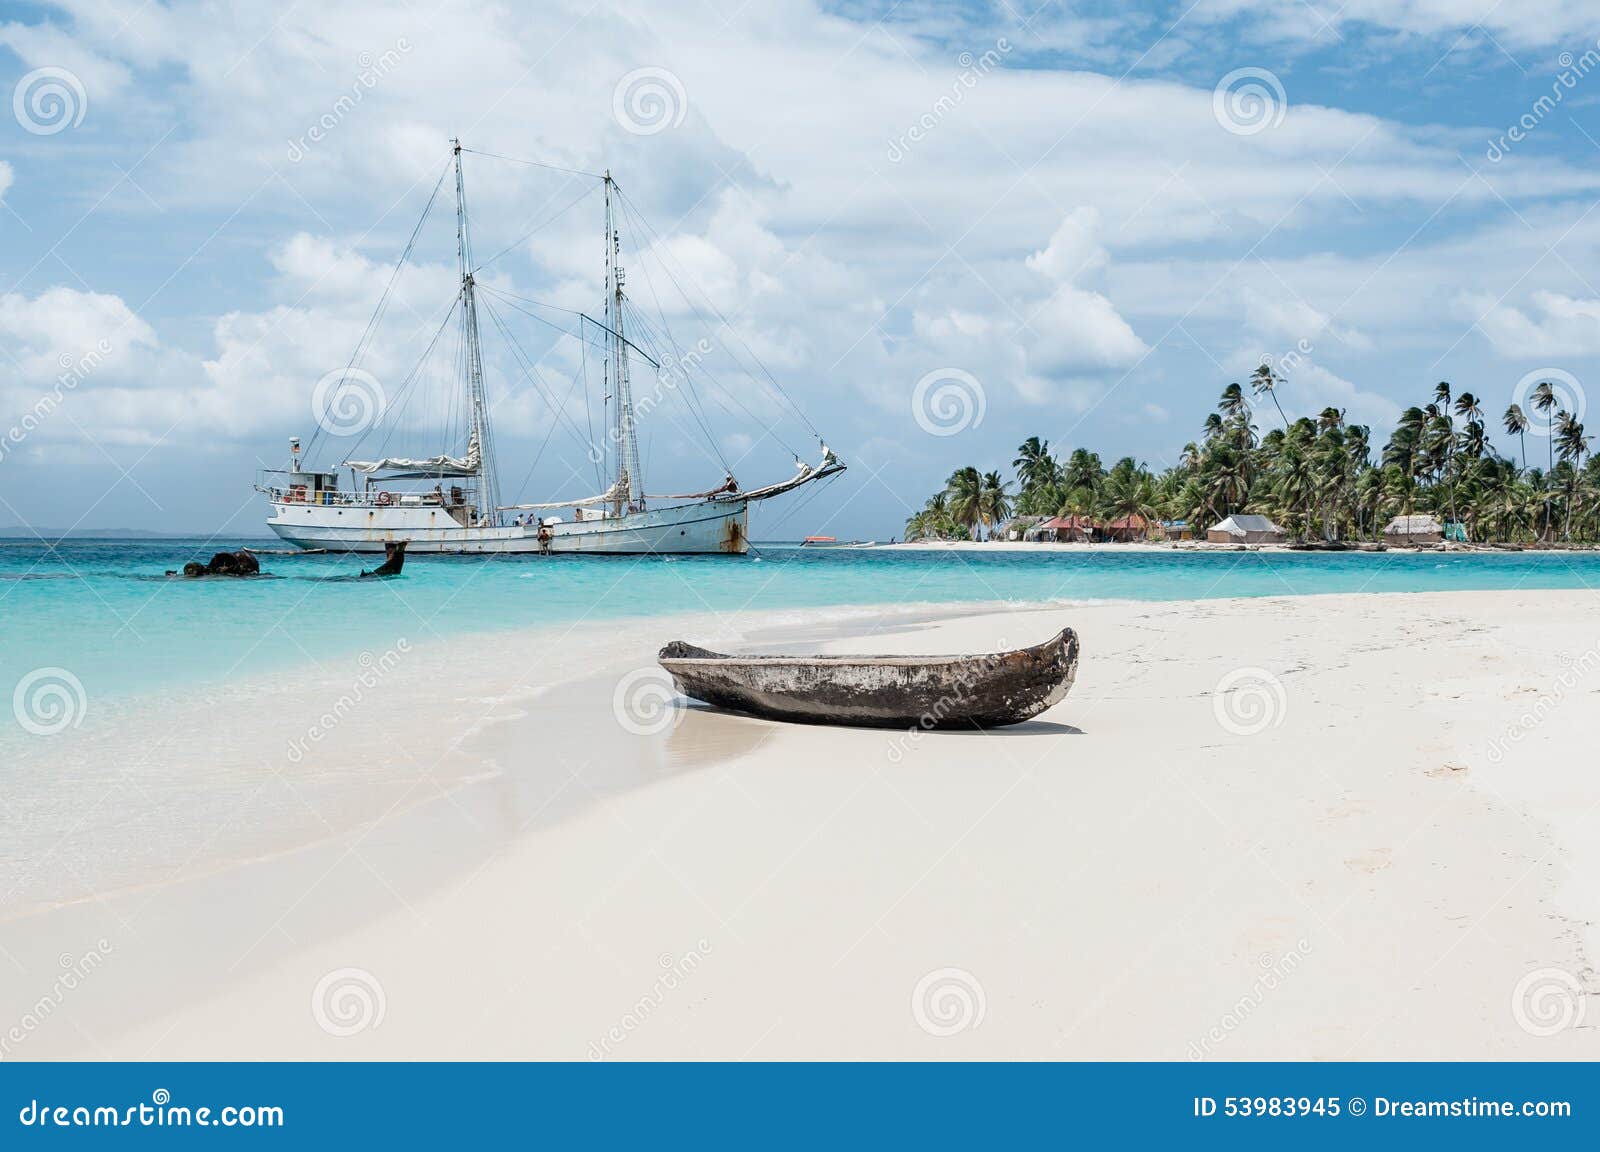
0, 0, 1600, 536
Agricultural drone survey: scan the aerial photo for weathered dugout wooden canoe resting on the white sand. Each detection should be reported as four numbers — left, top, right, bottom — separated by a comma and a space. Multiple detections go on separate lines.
659, 629, 1078, 728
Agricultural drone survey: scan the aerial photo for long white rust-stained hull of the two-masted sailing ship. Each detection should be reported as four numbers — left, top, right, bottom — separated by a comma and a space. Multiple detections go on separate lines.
267, 499, 750, 555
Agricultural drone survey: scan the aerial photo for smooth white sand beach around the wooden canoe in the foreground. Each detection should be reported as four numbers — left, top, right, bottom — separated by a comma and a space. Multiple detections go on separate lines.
0, 590, 1600, 1061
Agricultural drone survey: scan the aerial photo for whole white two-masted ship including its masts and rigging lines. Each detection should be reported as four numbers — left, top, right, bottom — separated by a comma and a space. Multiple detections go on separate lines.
256, 141, 845, 554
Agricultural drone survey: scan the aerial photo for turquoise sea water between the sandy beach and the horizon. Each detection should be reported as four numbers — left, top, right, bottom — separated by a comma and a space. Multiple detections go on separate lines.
0, 539, 1600, 710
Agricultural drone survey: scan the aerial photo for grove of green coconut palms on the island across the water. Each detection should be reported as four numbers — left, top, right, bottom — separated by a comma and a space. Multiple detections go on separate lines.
906, 365, 1600, 544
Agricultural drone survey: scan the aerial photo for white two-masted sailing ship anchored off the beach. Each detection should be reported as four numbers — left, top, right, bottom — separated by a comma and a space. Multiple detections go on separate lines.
256, 139, 845, 555
